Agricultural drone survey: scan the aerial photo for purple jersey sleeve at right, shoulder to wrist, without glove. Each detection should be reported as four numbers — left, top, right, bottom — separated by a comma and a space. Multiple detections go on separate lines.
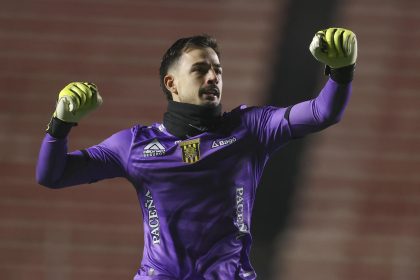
242, 79, 351, 153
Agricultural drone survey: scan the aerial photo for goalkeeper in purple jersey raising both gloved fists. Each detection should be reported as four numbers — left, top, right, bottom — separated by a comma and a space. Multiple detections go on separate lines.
37, 28, 357, 279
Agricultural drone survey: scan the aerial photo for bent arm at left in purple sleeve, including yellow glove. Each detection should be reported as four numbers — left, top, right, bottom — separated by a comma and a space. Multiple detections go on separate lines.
36, 82, 124, 188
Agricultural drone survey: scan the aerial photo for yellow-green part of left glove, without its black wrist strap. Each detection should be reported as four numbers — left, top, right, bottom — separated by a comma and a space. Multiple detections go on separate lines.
53, 82, 102, 123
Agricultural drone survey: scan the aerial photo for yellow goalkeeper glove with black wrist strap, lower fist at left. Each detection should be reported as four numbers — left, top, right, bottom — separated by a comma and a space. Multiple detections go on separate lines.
47, 82, 102, 138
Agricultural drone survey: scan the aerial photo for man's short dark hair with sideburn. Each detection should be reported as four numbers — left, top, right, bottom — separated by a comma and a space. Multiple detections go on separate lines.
159, 34, 220, 100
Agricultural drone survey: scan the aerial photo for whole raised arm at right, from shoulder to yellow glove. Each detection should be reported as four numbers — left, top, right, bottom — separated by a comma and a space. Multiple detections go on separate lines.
244, 28, 357, 154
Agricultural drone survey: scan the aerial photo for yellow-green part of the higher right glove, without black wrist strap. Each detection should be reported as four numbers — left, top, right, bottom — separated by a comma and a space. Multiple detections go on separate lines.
309, 28, 357, 69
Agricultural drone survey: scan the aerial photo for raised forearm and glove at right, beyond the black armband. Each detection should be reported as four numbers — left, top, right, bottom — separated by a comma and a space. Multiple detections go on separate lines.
285, 28, 357, 138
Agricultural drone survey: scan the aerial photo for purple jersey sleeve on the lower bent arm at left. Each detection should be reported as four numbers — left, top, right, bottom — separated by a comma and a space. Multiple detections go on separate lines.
36, 129, 133, 188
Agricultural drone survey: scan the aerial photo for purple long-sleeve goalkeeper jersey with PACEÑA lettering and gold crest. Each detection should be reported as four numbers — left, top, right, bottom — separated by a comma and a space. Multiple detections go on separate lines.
37, 79, 351, 280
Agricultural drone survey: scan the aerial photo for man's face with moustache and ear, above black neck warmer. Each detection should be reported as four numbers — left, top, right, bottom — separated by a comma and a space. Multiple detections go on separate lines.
164, 48, 223, 107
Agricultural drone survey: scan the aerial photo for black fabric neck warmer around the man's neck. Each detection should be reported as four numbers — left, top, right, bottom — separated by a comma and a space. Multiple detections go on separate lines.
163, 100, 222, 139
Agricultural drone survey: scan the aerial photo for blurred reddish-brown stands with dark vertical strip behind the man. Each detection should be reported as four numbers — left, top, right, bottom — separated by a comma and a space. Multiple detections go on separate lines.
0, 0, 420, 280
